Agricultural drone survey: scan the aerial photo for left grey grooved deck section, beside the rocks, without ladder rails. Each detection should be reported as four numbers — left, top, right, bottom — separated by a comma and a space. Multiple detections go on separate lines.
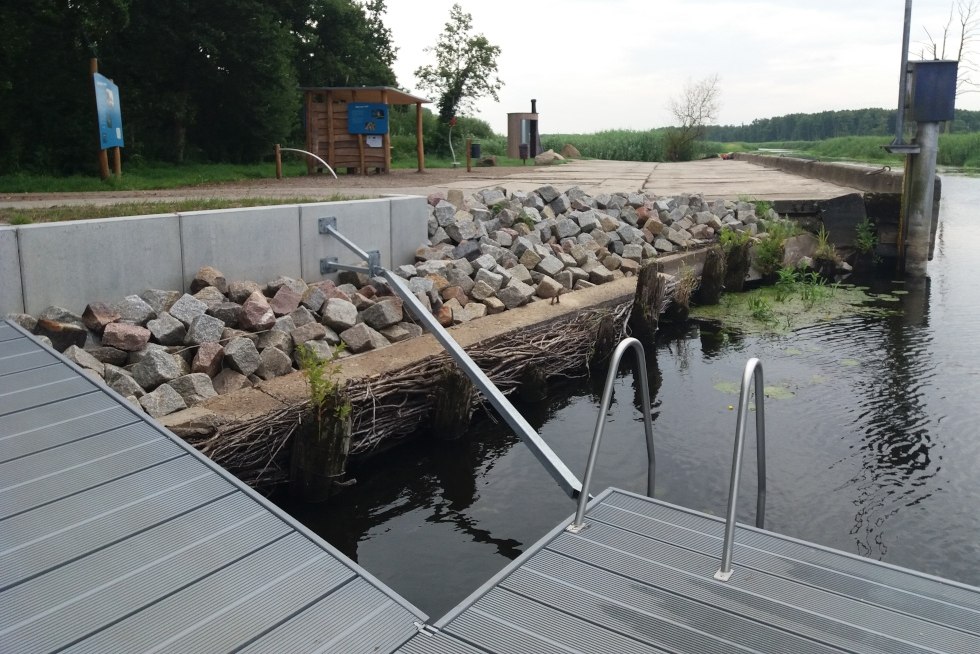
0, 321, 426, 653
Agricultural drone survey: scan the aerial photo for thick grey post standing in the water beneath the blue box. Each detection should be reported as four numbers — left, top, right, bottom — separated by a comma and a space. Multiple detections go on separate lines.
904, 123, 939, 277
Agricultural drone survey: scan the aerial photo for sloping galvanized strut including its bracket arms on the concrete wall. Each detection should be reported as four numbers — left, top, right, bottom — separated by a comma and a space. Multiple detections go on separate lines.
318, 223, 582, 499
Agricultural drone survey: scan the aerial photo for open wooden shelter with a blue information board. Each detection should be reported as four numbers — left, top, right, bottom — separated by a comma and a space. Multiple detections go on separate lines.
302, 86, 429, 175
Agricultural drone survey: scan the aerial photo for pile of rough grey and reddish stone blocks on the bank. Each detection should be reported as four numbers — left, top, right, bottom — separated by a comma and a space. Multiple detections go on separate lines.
10, 186, 772, 417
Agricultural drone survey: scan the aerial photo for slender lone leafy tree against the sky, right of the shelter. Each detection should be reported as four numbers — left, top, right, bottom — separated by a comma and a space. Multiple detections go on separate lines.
415, 4, 504, 124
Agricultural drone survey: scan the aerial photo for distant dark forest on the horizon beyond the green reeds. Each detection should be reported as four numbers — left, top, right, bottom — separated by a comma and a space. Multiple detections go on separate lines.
706, 109, 980, 143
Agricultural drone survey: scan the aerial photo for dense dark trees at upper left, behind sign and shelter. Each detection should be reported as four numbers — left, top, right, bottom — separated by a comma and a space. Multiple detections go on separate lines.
0, 0, 396, 173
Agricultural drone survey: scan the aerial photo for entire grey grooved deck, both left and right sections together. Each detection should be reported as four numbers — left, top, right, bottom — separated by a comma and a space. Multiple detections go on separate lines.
0, 322, 980, 654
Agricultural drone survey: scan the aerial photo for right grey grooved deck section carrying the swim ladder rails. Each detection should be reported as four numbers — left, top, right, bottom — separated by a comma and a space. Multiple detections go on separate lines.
414, 489, 980, 654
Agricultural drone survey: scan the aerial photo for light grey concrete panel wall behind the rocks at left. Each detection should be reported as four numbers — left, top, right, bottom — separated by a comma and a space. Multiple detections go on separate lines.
0, 197, 428, 314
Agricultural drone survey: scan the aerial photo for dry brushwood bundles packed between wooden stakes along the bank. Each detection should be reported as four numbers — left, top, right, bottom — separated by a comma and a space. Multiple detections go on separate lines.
192, 301, 632, 489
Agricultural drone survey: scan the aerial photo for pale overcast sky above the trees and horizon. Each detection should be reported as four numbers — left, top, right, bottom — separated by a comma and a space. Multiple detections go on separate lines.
386, 0, 980, 134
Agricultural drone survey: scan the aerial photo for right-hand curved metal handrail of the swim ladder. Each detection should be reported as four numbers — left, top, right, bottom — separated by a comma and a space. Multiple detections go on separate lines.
715, 358, 766, 581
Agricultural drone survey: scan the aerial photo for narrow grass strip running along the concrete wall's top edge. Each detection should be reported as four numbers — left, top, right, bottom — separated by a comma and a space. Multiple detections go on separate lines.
0, 195, 355, 225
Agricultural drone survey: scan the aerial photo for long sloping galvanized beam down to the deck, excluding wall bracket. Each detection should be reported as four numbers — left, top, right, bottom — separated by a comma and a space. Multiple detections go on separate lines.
380, 269, 582, 498
